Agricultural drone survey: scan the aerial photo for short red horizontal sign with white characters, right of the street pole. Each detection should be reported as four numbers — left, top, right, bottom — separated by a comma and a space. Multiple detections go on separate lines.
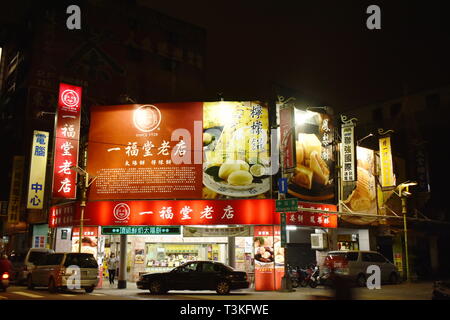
286, 202, 338, 228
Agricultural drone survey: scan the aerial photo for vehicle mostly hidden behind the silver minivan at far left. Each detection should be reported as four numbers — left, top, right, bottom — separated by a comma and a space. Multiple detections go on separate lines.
9, 248, 54, 284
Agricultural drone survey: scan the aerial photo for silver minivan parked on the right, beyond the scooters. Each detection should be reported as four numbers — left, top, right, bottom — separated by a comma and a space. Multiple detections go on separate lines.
323, 251, 400, 287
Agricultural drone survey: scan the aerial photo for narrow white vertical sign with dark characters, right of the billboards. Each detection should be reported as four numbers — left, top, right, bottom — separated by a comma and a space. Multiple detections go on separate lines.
341, 125, 356, 182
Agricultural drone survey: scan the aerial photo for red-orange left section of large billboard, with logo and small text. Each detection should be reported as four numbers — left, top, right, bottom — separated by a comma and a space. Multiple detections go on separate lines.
87, 102, 203, 200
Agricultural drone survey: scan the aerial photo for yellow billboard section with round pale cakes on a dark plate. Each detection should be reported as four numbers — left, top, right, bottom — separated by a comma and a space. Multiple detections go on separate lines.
202, 101, 271, 199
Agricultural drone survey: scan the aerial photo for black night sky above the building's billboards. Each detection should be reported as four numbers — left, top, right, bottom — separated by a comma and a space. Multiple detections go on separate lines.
140, 0, 450, 109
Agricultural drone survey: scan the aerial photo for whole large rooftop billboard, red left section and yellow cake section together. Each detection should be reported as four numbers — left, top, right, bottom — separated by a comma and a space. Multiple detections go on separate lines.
87, 101, 271, 200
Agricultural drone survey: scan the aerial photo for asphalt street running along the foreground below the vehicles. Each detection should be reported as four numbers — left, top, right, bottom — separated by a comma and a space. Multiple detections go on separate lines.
0, 282, 432, 303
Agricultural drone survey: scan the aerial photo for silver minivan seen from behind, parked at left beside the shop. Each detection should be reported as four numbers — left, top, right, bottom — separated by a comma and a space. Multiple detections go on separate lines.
27, 253, 99, 293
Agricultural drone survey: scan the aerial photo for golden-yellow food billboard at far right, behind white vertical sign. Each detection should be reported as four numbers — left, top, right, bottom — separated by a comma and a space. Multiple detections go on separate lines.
342, 147, 377, 224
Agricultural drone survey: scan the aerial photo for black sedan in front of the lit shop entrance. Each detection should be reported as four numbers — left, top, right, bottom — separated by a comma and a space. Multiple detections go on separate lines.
137, 261, 250, 294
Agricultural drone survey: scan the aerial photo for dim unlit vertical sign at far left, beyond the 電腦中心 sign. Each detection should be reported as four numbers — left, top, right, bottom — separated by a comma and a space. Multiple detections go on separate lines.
8, 156, 25, 223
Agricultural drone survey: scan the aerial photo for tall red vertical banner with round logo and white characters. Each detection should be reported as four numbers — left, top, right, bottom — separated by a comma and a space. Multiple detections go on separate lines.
52, 83, 81, 199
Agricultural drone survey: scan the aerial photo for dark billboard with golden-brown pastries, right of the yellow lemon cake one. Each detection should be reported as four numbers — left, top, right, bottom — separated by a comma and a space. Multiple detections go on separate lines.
288, 108, 335, 203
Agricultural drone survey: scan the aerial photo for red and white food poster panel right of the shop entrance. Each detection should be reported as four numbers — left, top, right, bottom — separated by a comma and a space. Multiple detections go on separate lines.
254, 226, 284, 291
